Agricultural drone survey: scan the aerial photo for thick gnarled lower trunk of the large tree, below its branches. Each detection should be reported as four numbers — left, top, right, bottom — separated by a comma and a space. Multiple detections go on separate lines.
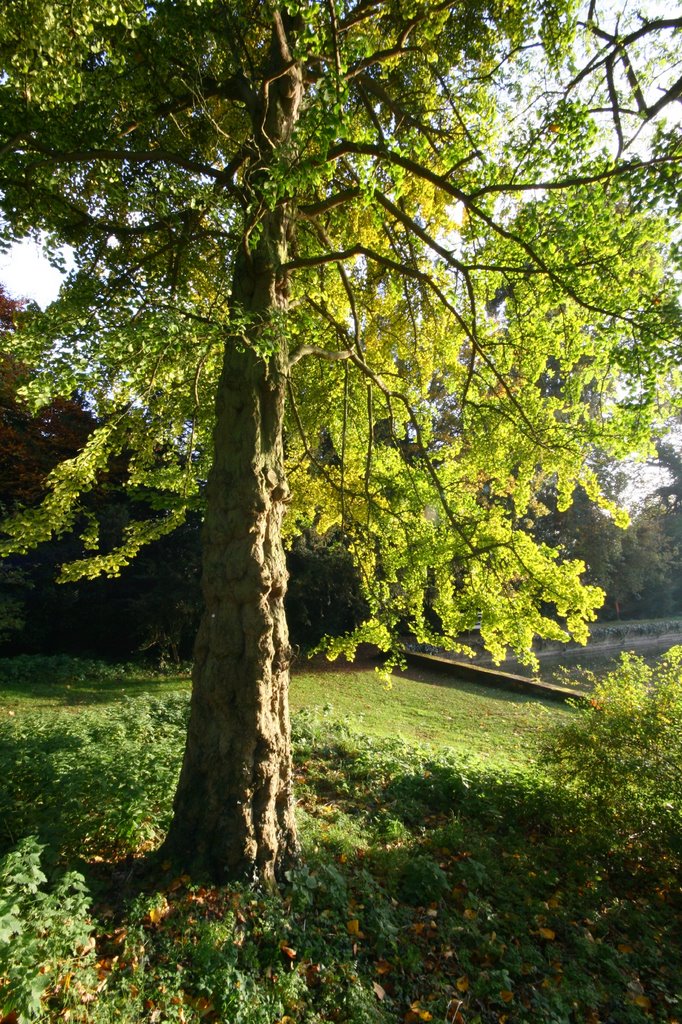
166, 317, 296, 883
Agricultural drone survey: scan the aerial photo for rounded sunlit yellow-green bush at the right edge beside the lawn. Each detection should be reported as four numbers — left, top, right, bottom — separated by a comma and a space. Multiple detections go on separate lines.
541, 646, 682, 857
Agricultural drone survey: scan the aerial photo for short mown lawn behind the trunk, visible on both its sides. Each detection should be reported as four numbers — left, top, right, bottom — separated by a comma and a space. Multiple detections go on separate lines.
0, 658, 570, 764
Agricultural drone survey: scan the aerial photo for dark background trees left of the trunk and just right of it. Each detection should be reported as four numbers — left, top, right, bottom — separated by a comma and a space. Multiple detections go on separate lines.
0, 287, 356, 663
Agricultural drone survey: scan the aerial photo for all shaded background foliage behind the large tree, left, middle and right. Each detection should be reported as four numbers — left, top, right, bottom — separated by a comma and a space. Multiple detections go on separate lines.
0, 287, 682, 662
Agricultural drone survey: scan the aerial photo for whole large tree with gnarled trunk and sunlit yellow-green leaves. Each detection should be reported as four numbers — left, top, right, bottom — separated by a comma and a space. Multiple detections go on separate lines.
0, 0, 682, 882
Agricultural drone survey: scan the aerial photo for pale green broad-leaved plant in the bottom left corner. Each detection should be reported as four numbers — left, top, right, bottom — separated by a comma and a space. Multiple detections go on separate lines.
0, 837, 95, 1021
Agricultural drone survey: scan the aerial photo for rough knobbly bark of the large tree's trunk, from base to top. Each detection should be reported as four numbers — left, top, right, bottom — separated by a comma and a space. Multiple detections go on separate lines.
164, 16, 303, 884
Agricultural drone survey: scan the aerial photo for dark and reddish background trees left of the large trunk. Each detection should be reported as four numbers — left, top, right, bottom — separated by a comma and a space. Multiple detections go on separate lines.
0, 288, 200, 660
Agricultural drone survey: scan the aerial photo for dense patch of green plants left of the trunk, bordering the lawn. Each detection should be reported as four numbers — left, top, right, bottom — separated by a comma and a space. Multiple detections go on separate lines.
0, 693, 187, 858
